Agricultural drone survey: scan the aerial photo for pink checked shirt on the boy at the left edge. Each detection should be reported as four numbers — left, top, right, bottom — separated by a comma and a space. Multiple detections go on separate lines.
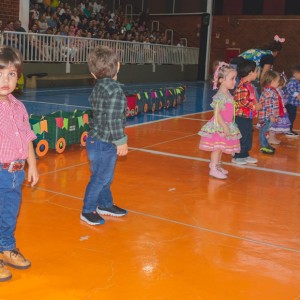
0, 94, 36, 163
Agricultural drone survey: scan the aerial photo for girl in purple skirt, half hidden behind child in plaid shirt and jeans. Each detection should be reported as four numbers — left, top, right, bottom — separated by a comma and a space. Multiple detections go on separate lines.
268, 73, 291, 145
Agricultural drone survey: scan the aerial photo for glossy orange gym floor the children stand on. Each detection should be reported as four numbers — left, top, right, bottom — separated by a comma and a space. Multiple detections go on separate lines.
0, 82, 300, 300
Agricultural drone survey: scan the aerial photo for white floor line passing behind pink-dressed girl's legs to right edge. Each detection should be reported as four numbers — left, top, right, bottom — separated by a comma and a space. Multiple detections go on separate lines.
129, 146, 300, 177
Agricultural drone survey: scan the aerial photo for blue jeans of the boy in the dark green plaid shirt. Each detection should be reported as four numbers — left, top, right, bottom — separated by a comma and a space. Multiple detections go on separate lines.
82, 137, 117, 213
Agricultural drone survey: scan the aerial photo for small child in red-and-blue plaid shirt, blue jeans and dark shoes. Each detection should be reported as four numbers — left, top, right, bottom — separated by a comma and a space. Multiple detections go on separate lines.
258, 71, 284, 154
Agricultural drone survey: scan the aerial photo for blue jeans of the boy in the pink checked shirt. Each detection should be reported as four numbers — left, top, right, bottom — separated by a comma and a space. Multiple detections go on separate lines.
0, 166, 25, 251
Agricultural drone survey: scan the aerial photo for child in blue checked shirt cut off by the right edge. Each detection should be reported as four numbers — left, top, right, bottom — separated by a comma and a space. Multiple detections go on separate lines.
285, 65, 300, 137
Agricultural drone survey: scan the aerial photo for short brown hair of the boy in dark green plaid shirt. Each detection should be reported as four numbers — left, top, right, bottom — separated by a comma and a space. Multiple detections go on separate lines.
88, 46, 119, 79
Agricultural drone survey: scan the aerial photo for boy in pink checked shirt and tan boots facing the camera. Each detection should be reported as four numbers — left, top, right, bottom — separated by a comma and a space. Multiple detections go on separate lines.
0, 46, 39, 281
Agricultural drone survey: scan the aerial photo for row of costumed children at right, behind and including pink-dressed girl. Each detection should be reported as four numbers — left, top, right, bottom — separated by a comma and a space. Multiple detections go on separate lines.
199, 59, 300, 179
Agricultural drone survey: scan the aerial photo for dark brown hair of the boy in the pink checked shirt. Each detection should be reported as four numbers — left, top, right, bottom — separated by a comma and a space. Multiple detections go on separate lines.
0, 46, 23, 78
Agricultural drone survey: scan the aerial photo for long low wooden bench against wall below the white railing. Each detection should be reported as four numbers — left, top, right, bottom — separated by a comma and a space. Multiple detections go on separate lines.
26, 74, 94, 89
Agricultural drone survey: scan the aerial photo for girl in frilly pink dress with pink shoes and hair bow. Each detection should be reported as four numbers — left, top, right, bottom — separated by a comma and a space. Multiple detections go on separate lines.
199, 62, 241, 179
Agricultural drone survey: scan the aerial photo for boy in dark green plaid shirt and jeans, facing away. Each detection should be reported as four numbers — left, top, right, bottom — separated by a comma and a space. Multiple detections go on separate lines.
80, 47, 128, 225
